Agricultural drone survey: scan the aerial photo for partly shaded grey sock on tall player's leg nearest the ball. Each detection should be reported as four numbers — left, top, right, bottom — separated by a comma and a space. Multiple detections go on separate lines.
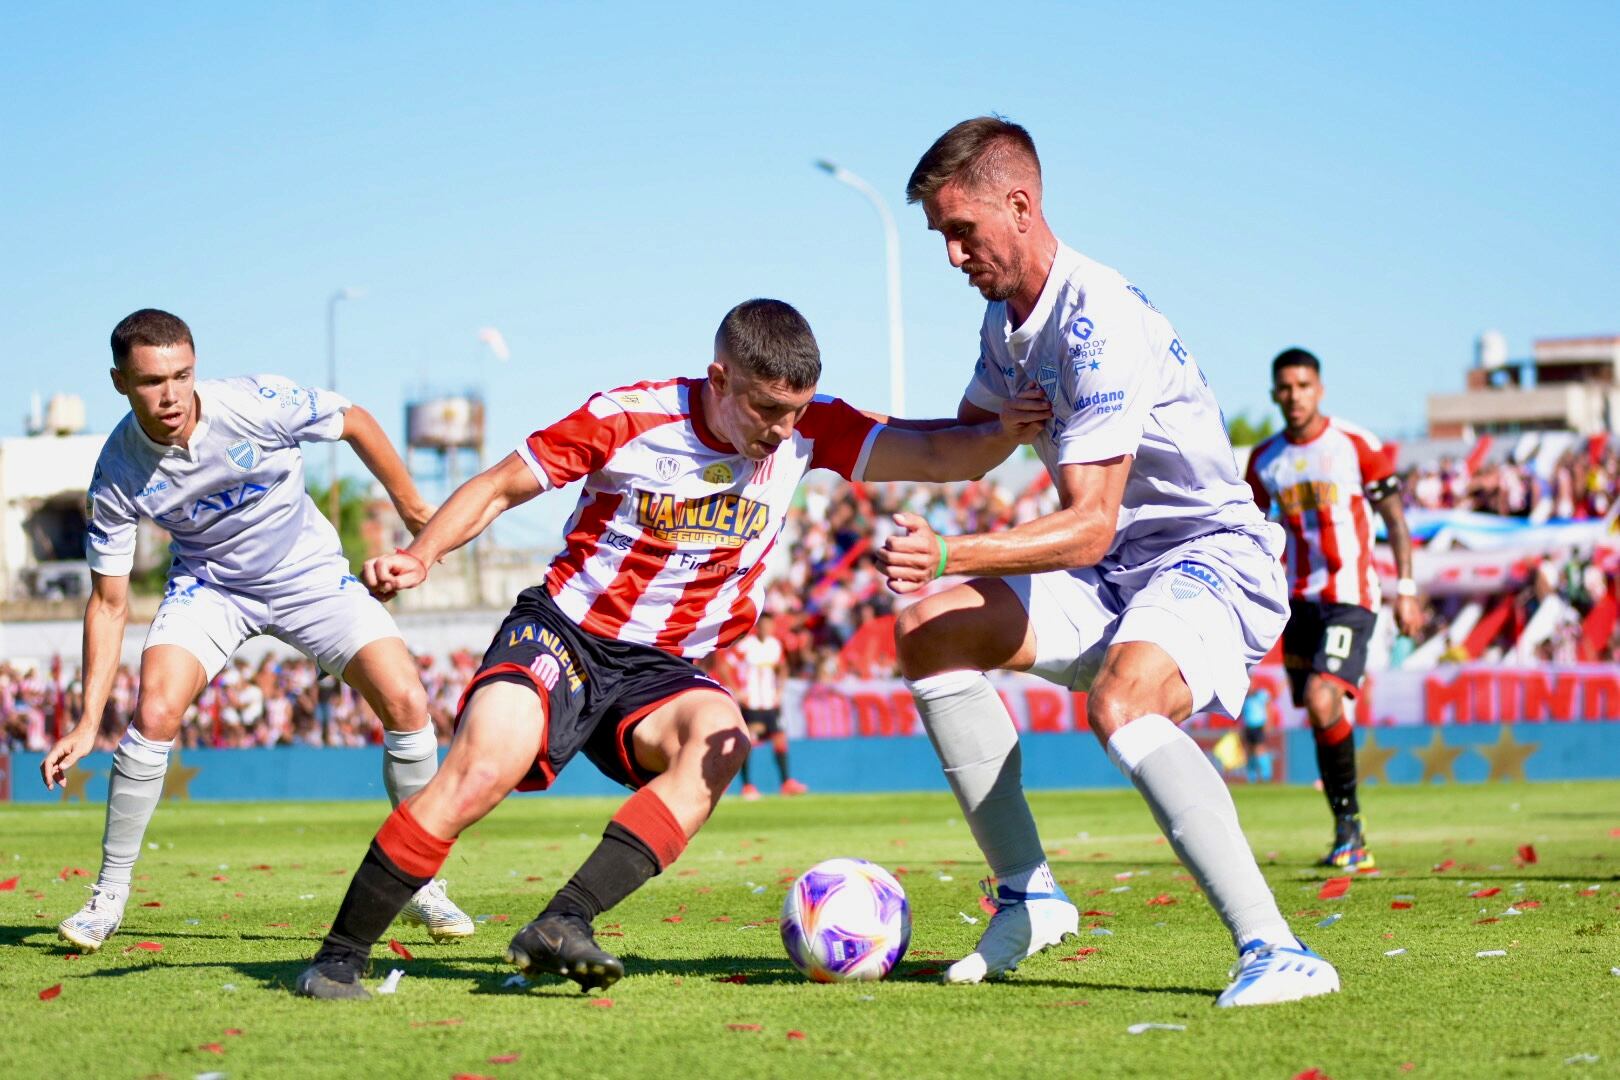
907, 672, 1056, 892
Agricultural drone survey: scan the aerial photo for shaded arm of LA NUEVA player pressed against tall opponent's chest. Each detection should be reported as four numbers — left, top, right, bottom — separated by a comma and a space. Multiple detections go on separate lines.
862, 385, 1051, 484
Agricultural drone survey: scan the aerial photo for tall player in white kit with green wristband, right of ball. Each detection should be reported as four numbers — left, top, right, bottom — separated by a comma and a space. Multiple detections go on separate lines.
880, 117, 1338, 1006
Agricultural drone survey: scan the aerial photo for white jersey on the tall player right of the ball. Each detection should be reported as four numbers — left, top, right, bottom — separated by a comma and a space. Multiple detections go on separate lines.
966, 244, 1283, 572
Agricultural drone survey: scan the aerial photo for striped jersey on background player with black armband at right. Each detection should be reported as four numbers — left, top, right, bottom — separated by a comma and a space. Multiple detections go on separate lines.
1246, 418, 1395, 610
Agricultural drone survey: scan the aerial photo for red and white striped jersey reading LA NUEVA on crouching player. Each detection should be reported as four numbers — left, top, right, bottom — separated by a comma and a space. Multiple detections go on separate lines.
518, 379, 881, 659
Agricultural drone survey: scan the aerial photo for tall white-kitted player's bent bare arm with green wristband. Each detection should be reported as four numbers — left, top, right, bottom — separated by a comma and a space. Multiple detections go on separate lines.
878, 455, 1132, 593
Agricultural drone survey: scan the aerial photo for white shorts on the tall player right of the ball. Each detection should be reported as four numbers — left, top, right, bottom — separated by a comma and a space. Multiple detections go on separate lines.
1004, 533, 1288, 717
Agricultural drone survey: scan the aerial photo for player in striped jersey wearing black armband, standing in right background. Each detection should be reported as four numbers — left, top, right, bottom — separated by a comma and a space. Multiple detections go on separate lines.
1247, 348, 1422, 870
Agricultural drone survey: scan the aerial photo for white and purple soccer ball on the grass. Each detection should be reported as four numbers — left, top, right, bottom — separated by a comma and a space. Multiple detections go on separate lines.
781, 858, 910, 983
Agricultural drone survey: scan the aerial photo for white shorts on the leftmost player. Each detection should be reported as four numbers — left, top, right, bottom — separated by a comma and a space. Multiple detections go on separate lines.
143, 560, 400, 678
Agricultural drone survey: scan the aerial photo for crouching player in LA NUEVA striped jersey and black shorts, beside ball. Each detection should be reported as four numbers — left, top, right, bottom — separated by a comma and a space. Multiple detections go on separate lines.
296, 300, 1048, 997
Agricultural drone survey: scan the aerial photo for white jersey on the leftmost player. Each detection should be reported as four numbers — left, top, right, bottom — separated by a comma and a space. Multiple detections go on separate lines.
86, 376, 348, 591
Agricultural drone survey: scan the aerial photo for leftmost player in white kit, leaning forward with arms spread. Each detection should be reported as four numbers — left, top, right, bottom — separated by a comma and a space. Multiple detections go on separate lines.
41, 309, 473, 952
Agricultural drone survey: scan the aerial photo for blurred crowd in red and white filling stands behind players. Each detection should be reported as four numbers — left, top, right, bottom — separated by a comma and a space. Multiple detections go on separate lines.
0, 445, 1620, 750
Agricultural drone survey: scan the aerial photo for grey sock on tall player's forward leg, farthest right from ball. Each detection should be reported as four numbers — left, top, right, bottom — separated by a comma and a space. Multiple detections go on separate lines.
1108, 714, 1294, 949
